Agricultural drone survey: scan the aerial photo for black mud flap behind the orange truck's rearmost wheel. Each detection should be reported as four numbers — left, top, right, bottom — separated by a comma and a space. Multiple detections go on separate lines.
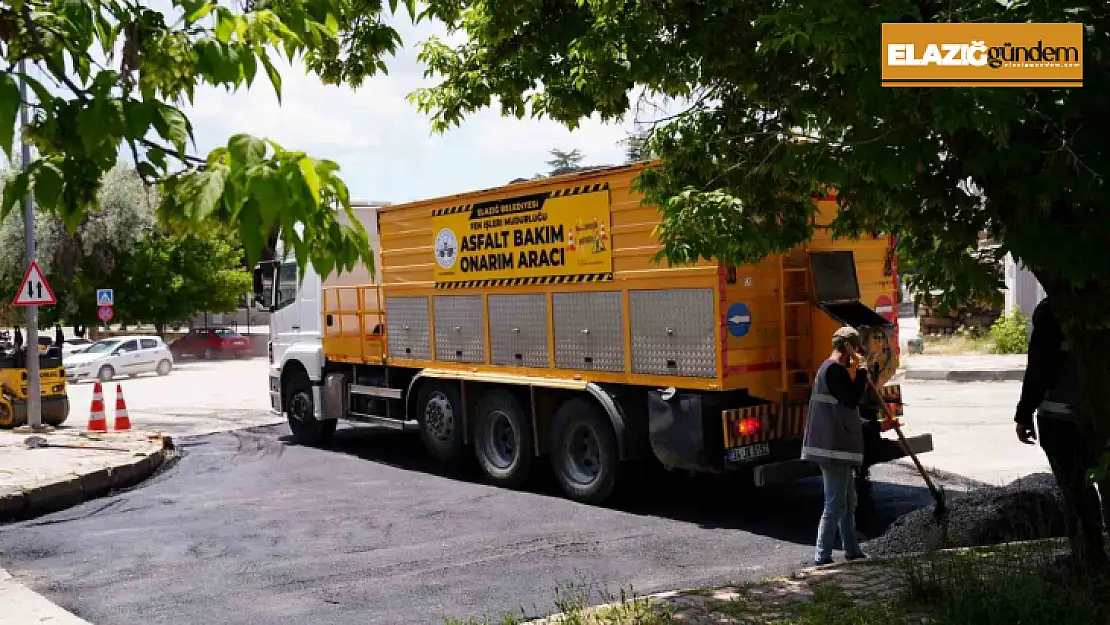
647, 391, 714, 472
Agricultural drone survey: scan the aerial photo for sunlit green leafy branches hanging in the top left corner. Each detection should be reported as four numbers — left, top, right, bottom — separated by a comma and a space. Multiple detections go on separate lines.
0, 0, 415, 274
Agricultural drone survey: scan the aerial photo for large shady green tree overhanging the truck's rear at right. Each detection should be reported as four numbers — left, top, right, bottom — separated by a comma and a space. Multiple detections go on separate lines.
413, 0, 1110, 563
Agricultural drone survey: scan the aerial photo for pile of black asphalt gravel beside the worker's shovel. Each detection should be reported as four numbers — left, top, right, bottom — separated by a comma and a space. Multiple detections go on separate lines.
864, 473, 1064, 555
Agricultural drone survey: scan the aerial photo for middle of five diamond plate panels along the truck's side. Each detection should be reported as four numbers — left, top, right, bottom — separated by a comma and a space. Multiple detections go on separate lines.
488, 294, 548, 366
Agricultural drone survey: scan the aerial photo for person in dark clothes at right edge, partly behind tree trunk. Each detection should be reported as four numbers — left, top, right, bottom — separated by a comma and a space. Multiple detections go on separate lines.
1013, 298, 1110, 563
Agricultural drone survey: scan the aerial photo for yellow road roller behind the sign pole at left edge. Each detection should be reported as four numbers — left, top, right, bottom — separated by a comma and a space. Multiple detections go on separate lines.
0, 350, 69, 429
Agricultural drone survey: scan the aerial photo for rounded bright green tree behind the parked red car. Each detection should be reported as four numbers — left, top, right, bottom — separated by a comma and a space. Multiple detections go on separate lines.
120, 229, 251, 334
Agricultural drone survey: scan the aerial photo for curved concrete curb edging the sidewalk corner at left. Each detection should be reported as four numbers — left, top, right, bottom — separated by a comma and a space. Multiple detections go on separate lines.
0, 436, 174, 522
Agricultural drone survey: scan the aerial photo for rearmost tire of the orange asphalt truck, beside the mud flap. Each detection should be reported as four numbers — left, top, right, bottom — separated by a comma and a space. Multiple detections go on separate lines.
551, 397, 620, 504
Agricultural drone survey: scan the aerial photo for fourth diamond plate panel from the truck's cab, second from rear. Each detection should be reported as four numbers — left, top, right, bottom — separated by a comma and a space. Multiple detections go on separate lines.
552, 291, 625, 371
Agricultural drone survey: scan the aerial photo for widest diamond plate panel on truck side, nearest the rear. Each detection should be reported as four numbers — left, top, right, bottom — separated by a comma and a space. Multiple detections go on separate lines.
628, 289, 719, 377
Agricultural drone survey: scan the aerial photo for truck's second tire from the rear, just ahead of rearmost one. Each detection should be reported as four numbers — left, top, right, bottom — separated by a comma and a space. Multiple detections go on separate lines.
473, 391, 535, 488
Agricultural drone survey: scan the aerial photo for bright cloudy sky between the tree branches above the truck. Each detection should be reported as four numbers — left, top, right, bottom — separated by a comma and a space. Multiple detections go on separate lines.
179, 13, 633, 202
